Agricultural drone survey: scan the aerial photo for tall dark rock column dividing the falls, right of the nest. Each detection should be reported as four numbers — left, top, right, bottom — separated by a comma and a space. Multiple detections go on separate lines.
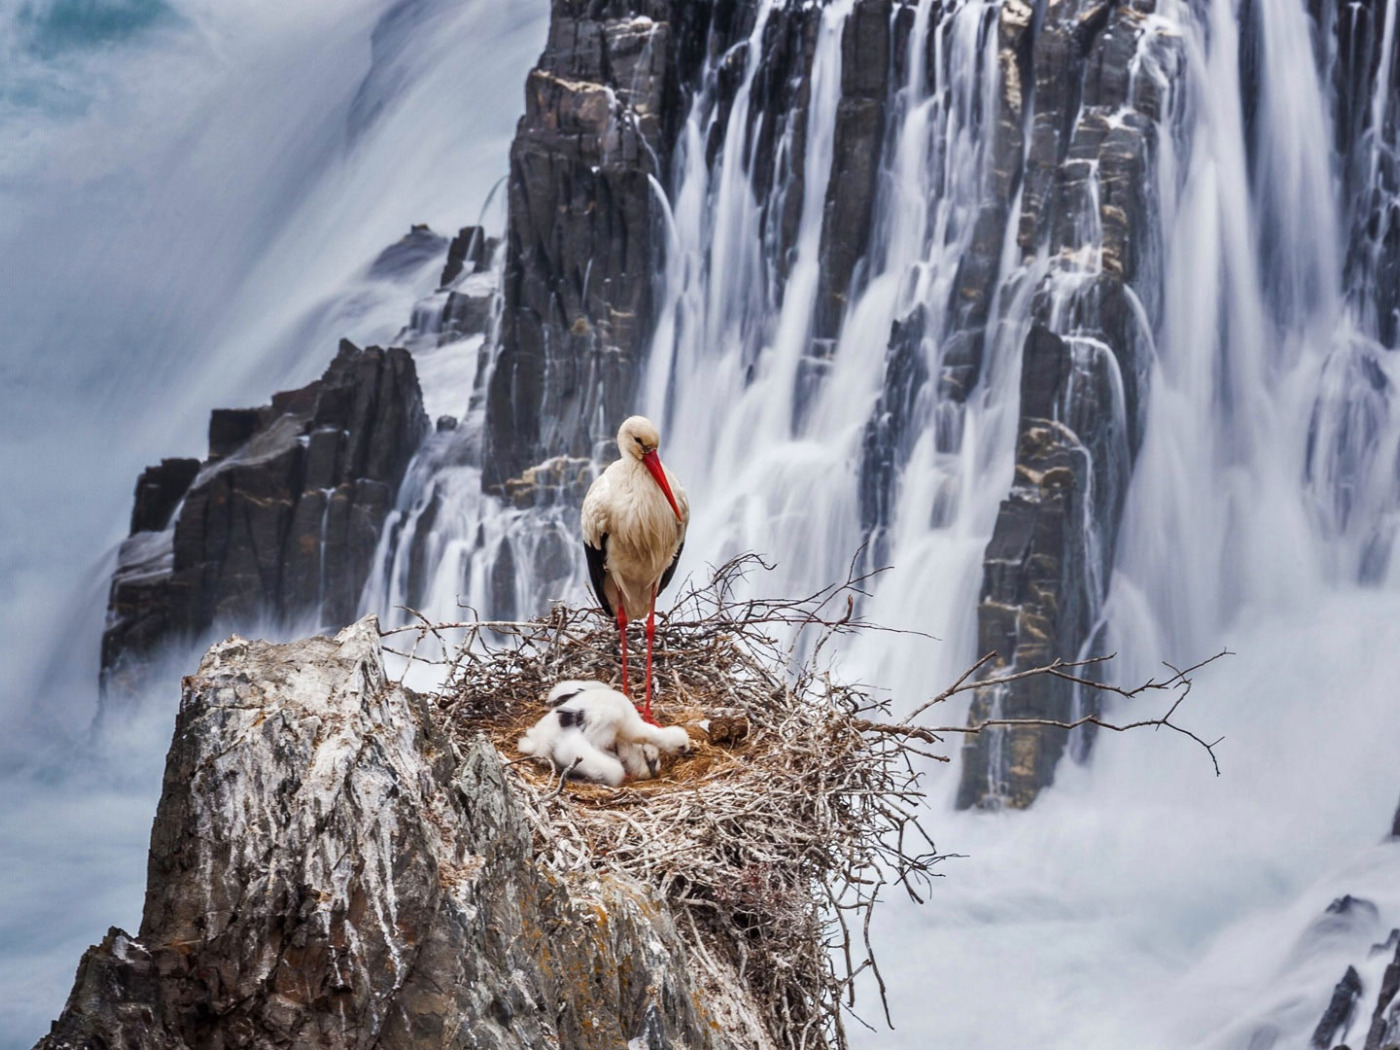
958, 0, 1179, 808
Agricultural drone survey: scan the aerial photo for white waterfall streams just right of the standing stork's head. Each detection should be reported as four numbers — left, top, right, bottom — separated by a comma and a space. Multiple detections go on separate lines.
643, 3, 872, 599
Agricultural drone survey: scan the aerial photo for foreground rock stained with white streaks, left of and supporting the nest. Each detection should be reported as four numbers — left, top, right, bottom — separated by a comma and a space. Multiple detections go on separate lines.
39, 619, 725, 1050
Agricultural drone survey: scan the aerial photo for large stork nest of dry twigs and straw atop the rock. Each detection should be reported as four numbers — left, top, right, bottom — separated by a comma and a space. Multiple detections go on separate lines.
389, 556, 941, 1049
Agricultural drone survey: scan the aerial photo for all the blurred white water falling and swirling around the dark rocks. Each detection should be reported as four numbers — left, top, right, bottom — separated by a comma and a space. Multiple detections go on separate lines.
0, 0, 1400, 1050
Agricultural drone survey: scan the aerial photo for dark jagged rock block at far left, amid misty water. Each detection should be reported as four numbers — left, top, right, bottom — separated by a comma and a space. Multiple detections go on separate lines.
102, 342, 427, 687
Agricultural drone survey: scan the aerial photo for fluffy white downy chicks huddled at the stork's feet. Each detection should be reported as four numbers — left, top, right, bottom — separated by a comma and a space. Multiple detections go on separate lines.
515, 680, 690, 787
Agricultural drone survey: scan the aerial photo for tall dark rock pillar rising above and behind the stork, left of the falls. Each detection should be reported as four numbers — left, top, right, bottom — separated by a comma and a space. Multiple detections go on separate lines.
484, 0, 708, 489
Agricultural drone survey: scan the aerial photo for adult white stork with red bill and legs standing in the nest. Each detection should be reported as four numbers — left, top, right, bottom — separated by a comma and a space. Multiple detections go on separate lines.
582, 416, 690, 721
